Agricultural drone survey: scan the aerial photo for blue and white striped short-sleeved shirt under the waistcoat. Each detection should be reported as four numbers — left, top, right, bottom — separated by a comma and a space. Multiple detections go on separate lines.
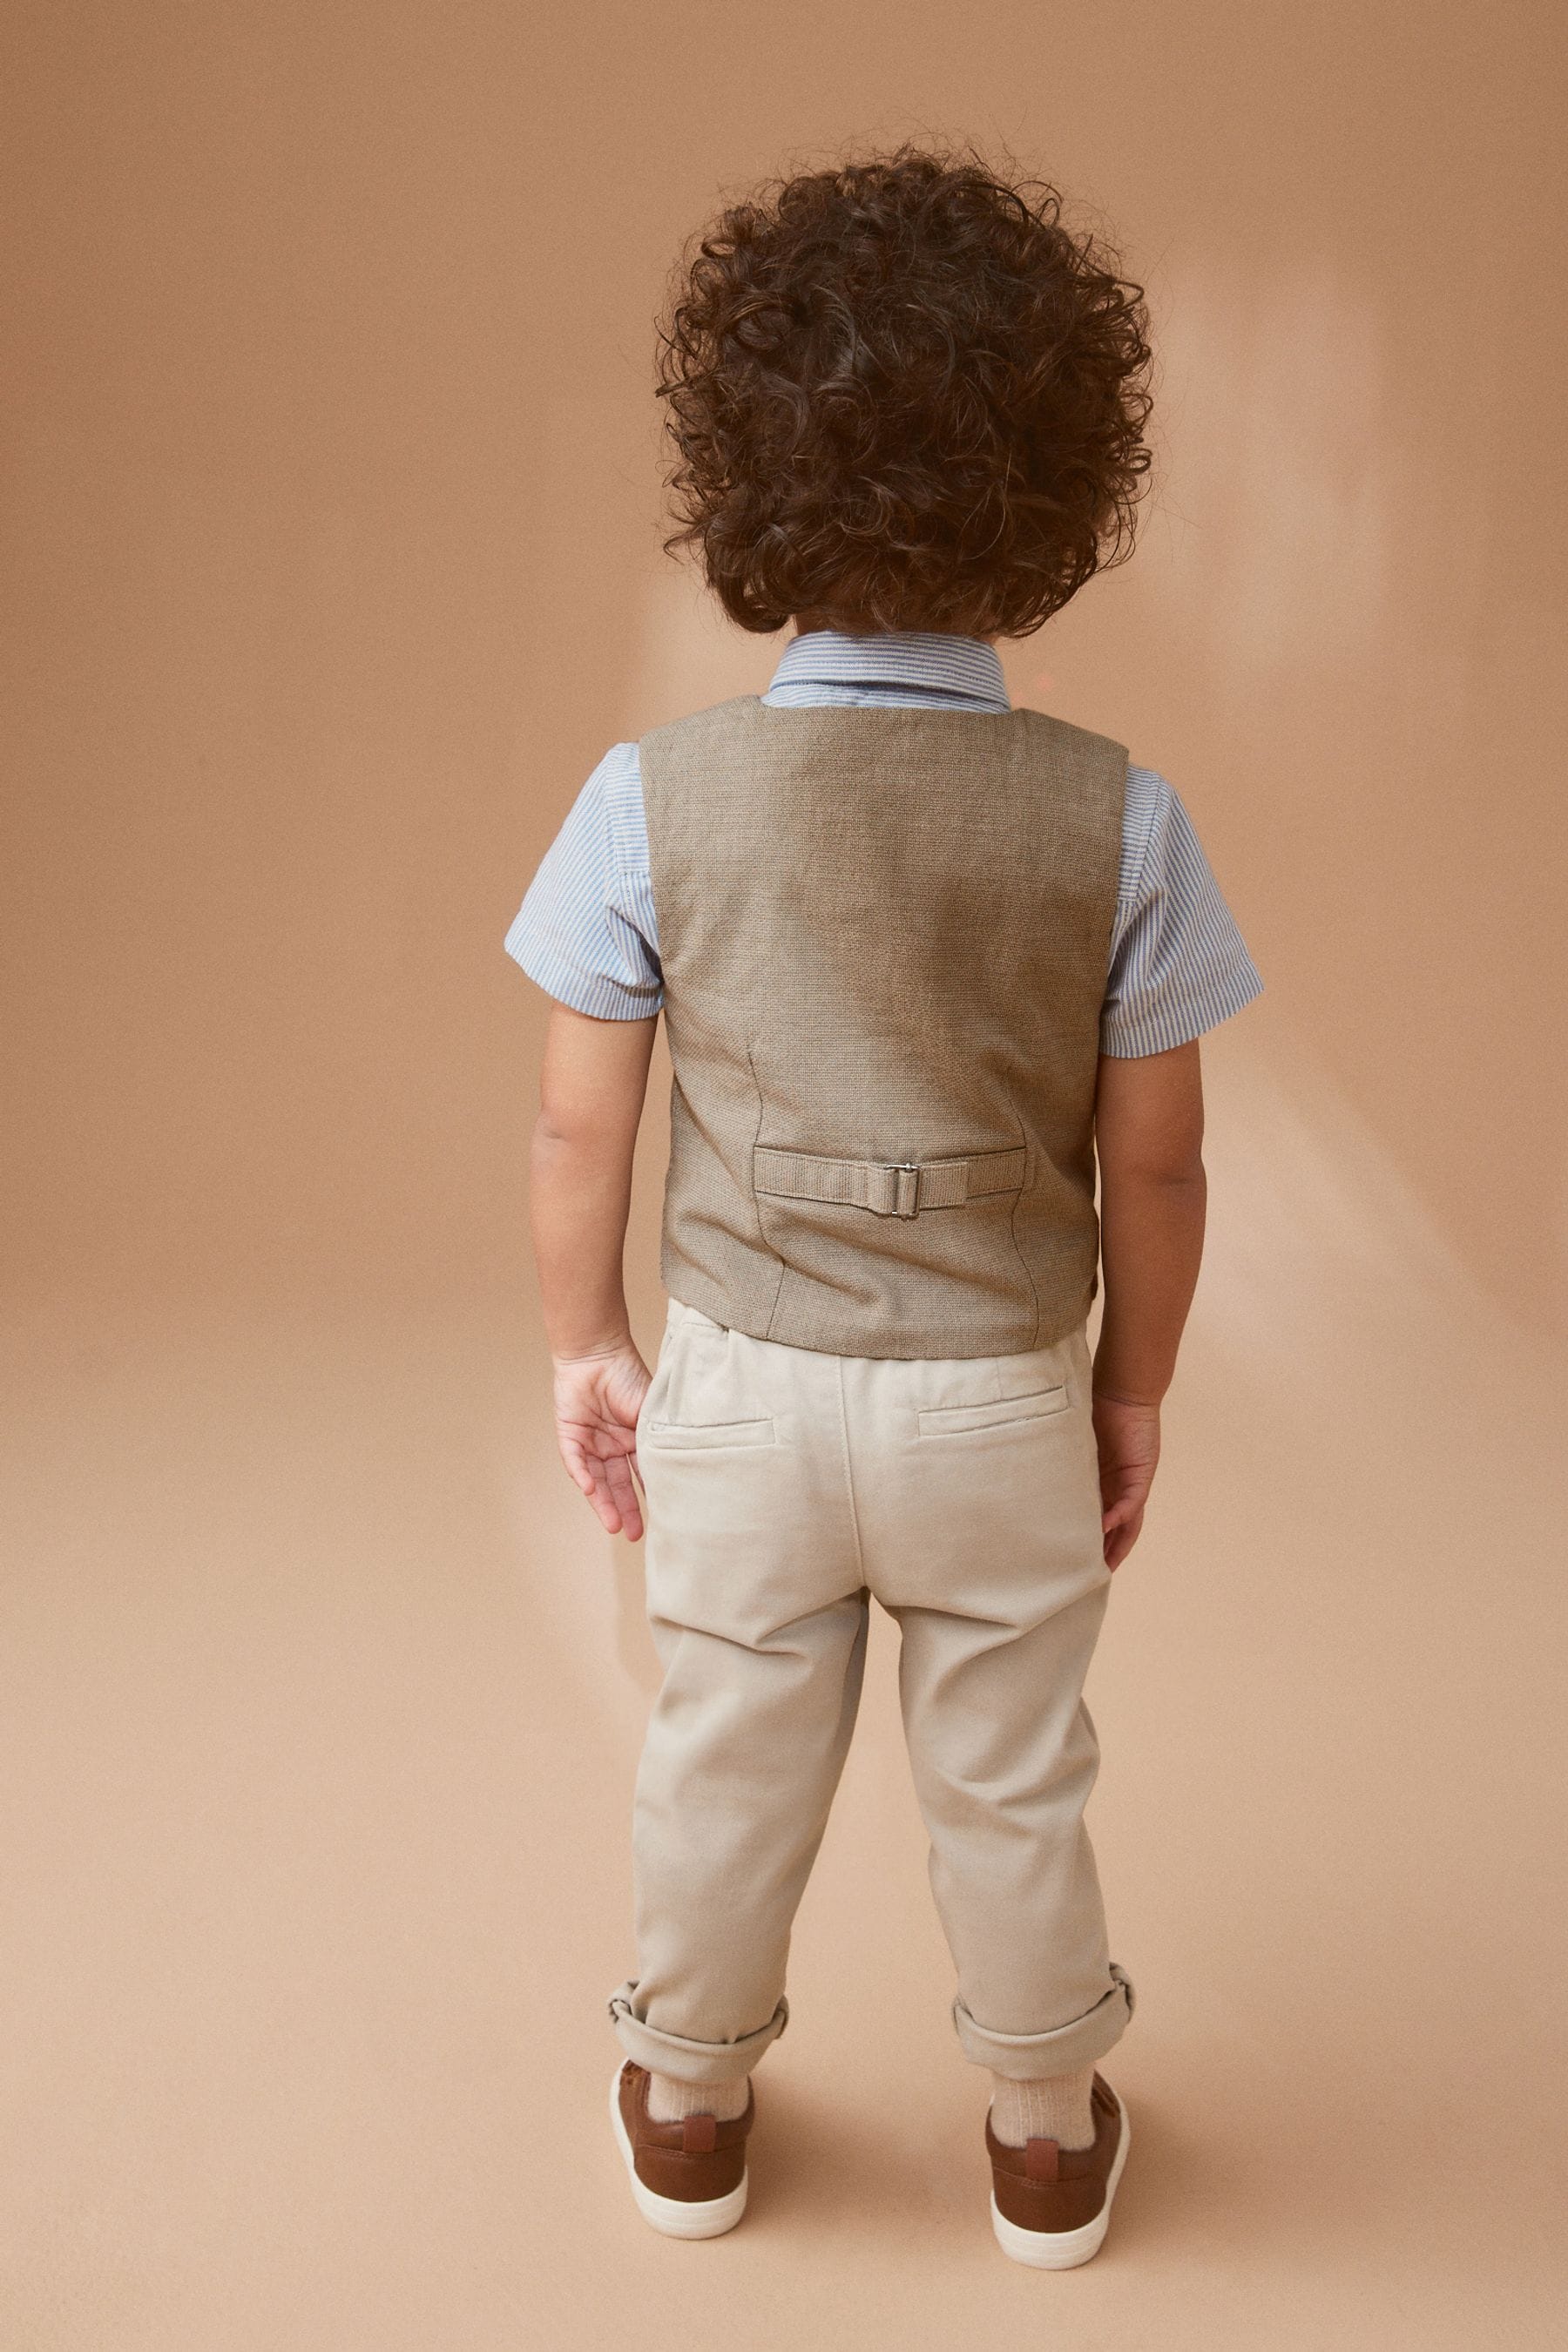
505, 628, 1262, 1058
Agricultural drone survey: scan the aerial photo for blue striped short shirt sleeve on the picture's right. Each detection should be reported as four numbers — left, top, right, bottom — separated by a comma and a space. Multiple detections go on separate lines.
1100, 767, 1262, 1058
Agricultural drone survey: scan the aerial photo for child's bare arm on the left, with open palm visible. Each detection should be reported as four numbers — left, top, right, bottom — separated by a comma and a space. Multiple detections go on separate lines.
529, 1002, 659, 1543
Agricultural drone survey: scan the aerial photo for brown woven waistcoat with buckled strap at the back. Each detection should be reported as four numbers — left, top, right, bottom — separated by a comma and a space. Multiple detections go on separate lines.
637, 694, 1128, 1357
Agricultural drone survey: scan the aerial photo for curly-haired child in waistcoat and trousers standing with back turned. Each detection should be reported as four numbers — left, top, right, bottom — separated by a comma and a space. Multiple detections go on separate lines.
508, 145, 1260, 2270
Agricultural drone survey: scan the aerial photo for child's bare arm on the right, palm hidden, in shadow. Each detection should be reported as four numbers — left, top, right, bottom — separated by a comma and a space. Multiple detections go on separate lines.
1093, 1037, 1206, 1569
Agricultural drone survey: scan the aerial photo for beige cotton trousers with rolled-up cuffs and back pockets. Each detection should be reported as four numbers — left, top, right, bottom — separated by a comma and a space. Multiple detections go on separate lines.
609, 1298, 1133, 2082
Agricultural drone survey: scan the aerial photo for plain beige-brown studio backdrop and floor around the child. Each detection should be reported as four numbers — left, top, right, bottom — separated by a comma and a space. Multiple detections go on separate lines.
0, 0, 1568, 2352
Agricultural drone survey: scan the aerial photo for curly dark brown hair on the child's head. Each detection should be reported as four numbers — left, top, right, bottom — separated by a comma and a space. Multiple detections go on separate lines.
659, 144, 1152, 638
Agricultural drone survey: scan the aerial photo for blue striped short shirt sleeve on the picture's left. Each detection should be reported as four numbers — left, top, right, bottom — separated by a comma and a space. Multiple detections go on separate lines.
505, 743, 663, 1021
